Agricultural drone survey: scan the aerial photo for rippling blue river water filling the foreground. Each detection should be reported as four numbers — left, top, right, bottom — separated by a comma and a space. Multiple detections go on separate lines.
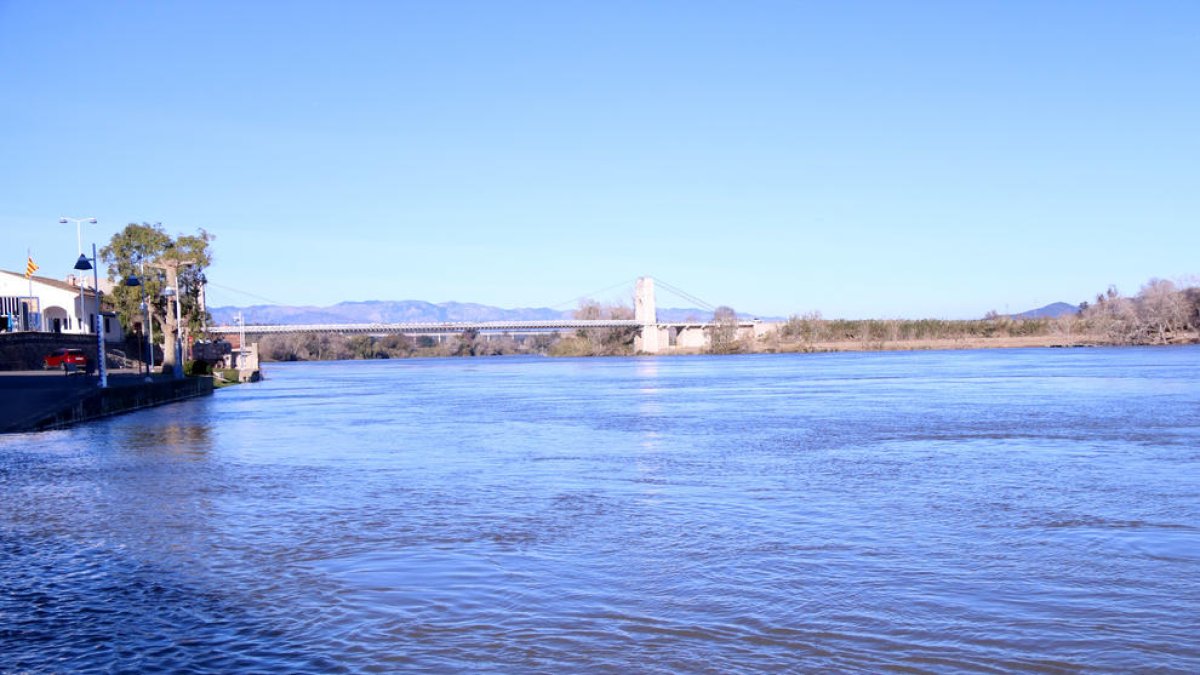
0, 347, 1200, 673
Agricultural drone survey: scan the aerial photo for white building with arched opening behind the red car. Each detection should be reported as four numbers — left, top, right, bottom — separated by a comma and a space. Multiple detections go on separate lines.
0, 270, 125, 344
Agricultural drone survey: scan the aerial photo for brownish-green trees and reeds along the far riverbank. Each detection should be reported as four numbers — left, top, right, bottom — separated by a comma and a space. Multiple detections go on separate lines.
259, 279, 1200, 362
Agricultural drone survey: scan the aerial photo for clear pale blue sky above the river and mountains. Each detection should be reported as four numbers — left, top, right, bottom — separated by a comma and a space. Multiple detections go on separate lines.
0, 0, 1200, 318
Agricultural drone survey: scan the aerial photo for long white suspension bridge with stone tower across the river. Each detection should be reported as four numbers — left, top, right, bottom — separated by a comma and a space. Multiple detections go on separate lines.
209, 276, 763, 354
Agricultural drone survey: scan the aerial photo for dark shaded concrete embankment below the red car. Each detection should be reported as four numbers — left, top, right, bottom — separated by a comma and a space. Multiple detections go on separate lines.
0, 374, 212, 434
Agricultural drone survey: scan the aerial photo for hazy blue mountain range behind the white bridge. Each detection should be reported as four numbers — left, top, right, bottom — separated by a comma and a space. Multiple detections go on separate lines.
209, 300, 734, 325
